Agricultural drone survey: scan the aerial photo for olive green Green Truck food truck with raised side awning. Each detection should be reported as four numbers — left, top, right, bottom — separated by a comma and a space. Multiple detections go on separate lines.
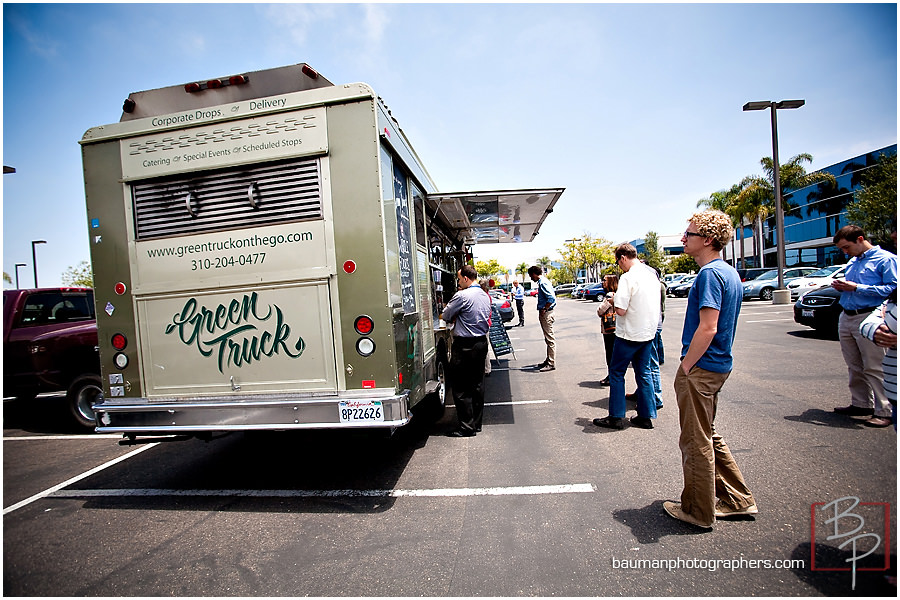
80, 64, 563, 441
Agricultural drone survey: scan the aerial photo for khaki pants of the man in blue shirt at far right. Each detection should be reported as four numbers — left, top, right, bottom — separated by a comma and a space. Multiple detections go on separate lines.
838, 313, 891, 419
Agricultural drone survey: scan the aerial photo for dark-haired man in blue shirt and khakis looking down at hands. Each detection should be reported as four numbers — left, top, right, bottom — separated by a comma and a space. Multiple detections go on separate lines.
831, 225, 897, 427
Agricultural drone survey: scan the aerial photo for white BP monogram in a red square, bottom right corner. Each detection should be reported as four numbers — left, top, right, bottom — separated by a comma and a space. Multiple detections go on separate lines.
810, 496, 891, 590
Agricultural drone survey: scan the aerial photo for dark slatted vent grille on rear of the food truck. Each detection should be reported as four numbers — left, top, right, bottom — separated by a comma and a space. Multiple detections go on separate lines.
132, 158, 322, 240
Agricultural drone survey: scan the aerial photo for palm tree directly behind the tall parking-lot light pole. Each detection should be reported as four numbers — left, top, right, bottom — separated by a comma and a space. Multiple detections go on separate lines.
735, 152, 836, 266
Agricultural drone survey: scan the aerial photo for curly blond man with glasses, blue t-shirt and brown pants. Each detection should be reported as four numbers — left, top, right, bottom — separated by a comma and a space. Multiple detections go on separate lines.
663, 210, 759, 529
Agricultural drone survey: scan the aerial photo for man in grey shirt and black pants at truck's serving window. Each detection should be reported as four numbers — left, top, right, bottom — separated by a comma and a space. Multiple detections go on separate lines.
441, 265, 491, 437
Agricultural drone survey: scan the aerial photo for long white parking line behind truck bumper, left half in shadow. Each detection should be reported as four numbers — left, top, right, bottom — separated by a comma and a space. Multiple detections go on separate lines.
50, 483, 597, 498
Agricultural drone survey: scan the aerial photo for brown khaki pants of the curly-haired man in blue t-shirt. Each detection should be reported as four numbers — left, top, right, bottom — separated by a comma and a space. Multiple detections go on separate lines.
675, 365, 756, 525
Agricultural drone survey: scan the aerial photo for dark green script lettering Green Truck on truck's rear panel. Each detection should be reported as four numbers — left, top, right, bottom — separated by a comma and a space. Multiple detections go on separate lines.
166, 292, 306, 373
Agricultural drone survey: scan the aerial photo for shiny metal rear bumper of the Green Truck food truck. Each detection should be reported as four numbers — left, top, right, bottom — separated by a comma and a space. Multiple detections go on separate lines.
94, 390, 410, 434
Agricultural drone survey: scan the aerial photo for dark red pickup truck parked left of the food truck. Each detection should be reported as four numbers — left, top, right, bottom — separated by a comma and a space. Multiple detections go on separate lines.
3, 288, 103, 428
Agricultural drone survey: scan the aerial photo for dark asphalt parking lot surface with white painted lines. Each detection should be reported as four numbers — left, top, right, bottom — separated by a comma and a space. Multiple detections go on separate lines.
3, 298, 897, 596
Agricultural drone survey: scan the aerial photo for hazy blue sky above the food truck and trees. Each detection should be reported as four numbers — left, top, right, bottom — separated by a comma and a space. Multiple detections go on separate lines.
3, 3, 897, 287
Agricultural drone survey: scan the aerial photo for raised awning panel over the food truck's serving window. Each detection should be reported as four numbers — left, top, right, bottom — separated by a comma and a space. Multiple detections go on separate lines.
428, 188, 565, 244
